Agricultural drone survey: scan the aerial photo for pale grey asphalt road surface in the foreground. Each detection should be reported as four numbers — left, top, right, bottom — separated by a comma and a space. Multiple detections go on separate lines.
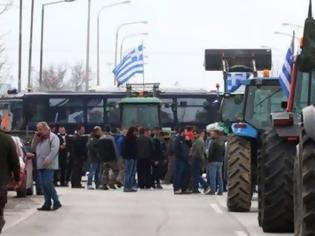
3, 187, 293, 236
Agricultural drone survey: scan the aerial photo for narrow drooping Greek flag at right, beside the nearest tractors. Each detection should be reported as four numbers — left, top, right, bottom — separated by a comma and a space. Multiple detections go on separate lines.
279, 34, 295, 97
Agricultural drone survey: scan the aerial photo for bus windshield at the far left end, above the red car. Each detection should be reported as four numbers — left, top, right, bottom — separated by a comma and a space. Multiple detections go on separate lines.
0, 99, 25, 131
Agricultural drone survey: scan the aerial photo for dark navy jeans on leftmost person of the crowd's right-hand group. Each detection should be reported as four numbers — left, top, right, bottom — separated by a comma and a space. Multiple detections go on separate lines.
173, 160, 189, 191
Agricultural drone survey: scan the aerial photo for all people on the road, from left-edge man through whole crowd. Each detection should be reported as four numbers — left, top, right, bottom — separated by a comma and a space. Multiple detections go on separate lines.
0, 122, 225, 232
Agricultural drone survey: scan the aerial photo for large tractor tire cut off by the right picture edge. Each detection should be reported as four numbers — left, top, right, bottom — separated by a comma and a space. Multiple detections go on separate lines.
294, 131, 315, 236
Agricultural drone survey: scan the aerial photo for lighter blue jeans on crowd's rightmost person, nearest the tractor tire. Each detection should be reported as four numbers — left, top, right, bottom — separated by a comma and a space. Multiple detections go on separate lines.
208, 162, 223, 193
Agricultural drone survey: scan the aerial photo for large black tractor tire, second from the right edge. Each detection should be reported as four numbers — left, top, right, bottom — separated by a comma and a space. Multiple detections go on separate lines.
260, 130, 296, 233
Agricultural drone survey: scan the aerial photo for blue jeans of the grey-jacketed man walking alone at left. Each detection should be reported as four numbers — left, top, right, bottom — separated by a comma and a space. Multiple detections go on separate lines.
39, 169, 60, 208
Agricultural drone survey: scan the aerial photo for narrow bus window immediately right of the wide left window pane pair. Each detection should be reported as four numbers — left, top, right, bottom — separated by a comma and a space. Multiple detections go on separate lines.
87, 98, 104, 124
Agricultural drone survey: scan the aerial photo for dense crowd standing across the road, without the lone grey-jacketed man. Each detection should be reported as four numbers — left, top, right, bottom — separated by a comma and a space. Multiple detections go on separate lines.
34, 121, 225, 196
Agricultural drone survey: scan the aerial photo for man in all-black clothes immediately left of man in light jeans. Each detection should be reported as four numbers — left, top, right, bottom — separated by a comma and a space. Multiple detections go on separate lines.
70, 125, 87, 188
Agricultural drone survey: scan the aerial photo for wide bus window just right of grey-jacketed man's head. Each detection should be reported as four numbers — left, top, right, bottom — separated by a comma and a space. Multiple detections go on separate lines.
49, 98, 84, 124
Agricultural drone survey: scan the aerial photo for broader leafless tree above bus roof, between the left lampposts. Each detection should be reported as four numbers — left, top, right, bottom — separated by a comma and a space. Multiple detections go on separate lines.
38, 66, 67, 91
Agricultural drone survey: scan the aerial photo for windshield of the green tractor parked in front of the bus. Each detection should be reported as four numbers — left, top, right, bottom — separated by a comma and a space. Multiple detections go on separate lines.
121, 104, 160, 129
